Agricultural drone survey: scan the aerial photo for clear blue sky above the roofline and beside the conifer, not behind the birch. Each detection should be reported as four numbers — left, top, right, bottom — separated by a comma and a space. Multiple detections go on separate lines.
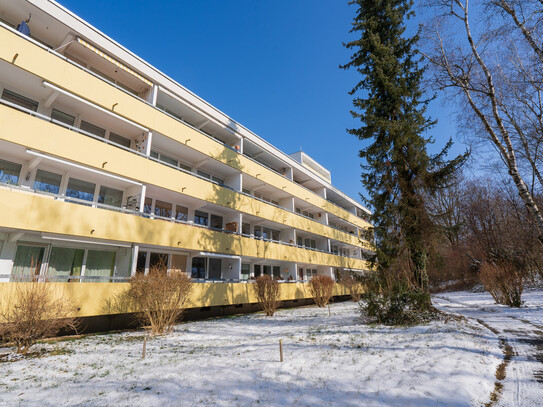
54, 0, 462, 207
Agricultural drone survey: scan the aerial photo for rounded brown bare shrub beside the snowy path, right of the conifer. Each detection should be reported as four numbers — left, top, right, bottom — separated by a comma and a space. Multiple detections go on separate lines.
479, 263, 526, 307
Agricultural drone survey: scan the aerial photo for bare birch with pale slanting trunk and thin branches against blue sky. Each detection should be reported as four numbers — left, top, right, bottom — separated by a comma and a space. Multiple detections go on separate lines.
425, 0, 543, 242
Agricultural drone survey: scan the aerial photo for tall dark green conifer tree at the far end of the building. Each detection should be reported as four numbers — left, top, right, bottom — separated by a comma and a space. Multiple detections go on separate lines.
341, 0, 467, 292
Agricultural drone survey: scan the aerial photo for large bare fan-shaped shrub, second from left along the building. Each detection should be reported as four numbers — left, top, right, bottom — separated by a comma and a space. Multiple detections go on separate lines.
127, 265, 192, 334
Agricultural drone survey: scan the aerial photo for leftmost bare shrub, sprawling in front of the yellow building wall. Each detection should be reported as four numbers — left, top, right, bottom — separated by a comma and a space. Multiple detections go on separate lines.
0, 281, 79, 355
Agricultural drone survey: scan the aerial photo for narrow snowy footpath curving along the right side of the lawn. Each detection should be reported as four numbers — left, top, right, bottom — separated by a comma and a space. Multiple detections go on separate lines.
434, 294, 543, 407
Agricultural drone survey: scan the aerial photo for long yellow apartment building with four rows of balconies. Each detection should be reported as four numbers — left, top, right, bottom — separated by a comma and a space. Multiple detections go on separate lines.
0, 0, 370, 316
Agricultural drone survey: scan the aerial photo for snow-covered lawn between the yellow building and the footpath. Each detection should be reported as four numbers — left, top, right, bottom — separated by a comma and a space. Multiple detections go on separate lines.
0, 300, 502, 406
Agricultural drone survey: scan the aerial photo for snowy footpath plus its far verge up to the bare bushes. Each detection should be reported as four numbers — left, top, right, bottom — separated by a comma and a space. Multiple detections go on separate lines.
434, 291, 543, 407
